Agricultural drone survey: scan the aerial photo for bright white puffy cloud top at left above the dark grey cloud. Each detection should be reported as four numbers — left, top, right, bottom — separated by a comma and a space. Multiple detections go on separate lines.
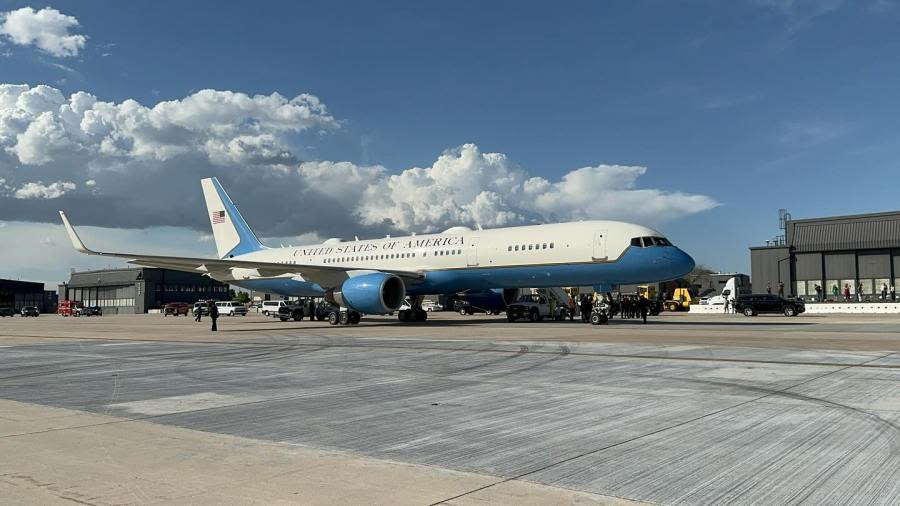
0, 84, 338, 165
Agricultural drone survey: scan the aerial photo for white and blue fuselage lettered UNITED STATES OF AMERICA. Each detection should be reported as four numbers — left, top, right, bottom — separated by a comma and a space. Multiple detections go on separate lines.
223, 221, 694, 296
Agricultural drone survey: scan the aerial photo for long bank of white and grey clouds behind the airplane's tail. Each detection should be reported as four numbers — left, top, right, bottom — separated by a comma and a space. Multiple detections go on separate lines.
0, 84, 717, 237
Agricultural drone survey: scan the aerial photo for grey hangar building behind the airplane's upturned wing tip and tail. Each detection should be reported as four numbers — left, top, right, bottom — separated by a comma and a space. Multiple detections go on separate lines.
58, 267, 231, 314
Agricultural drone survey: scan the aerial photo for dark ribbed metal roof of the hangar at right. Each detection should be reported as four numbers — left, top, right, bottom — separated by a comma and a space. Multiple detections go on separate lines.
787, 211, 900, 251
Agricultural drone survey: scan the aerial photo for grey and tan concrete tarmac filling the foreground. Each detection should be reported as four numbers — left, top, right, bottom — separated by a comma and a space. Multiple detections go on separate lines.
0, 313, 900, 504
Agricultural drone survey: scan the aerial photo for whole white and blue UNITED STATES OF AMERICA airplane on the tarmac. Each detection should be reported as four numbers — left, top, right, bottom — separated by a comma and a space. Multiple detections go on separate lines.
59, 177, 694, 325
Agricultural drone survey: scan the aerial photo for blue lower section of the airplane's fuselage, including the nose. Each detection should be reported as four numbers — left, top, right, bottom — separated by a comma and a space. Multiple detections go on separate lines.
232, 246, 694, 297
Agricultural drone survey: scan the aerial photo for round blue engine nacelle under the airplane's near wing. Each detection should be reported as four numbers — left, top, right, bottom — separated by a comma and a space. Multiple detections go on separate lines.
325, 272, 406, 314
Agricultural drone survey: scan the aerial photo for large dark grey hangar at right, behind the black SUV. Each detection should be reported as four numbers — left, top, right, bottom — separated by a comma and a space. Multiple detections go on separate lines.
750, 211, 900, 300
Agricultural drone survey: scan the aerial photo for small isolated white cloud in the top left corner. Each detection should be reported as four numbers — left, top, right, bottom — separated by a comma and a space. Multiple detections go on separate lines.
0, 7, 87, 58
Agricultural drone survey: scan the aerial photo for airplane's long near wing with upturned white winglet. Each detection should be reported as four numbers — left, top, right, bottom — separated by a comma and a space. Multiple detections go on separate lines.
59, 211, 425, 288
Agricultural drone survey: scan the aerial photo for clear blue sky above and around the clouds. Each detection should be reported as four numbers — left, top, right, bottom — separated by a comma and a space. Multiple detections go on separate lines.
0, 0, 900, 284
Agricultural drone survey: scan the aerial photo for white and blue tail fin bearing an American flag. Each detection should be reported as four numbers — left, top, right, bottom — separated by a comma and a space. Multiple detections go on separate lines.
200, 177, 265, 258
